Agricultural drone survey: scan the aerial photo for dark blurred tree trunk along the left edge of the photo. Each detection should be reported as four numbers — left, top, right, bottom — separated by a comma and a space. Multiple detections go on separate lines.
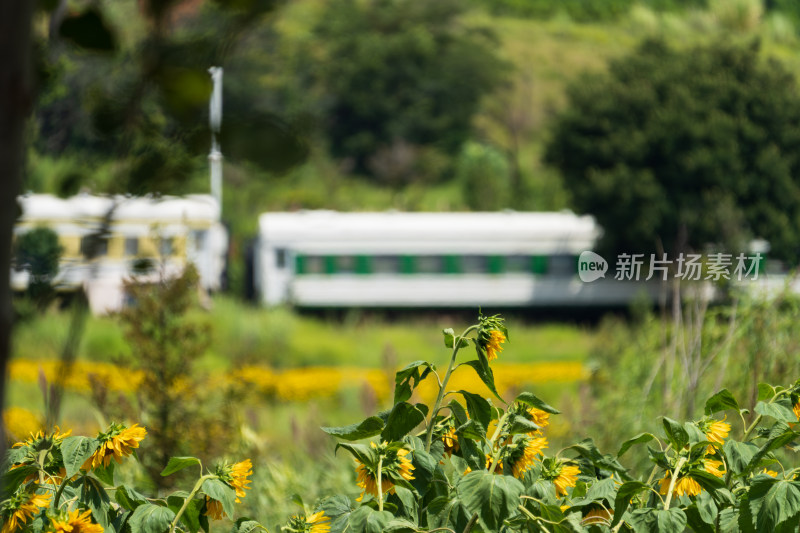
0, 0, 34, 448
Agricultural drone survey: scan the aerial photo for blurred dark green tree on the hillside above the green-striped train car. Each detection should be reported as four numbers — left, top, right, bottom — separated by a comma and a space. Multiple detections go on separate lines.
316, 0, 505, 182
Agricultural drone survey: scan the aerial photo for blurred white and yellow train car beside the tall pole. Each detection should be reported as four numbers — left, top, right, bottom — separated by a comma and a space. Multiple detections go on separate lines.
11, 194, 228, 314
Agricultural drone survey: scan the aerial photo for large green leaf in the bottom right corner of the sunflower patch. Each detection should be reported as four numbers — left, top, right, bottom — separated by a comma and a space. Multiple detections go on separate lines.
749, 474, 800, 531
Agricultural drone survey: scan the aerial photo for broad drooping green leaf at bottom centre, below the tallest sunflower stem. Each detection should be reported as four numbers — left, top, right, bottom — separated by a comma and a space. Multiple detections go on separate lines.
456, 470, 525, 530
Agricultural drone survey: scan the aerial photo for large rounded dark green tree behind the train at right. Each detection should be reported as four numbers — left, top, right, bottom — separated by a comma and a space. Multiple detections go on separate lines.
546, 41, 800, 261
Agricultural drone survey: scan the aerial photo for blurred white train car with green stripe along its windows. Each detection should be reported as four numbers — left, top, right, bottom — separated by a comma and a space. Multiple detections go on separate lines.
254, 211, 657, 308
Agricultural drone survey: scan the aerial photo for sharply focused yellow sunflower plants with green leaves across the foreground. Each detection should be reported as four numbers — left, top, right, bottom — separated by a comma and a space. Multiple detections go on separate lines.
0, 316, 800, 533
